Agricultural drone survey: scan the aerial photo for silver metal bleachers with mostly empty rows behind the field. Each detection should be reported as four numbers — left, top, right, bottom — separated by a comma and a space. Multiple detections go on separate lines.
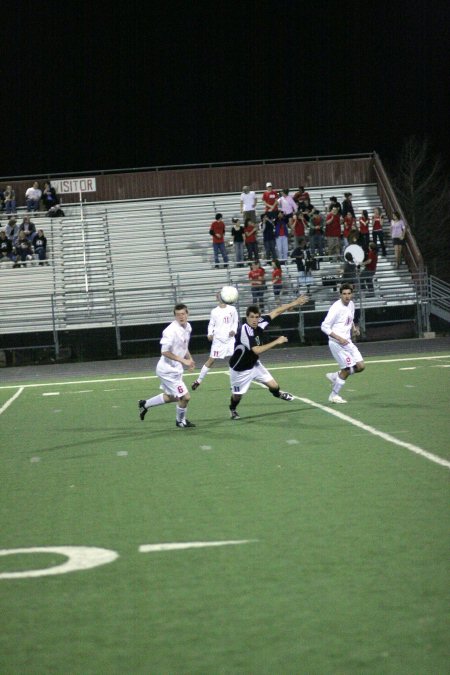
0, 184, 428, 344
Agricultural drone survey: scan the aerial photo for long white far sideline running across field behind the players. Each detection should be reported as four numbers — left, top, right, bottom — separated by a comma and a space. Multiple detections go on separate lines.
0, 354, 450, 390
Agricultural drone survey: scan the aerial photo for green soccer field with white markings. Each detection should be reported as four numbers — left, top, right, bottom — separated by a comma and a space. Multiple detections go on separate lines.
0, 353, 450, 675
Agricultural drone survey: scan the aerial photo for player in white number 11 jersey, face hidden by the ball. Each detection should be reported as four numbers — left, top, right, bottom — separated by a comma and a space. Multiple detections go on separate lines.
192, 293, 239, 391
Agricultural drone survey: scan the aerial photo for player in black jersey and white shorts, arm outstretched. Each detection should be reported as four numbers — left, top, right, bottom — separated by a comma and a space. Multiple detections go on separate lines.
229, 295, 309, 420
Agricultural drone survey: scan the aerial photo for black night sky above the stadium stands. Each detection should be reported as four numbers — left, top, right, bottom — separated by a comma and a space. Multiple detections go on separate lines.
4, 0, 450, 177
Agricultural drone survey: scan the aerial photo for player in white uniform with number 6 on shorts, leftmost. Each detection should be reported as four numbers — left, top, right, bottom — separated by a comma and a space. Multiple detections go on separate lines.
138, 304, 195, 429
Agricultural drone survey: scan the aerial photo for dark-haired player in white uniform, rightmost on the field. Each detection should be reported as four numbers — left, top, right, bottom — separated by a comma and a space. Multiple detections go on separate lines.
321, 284, 365, 403
